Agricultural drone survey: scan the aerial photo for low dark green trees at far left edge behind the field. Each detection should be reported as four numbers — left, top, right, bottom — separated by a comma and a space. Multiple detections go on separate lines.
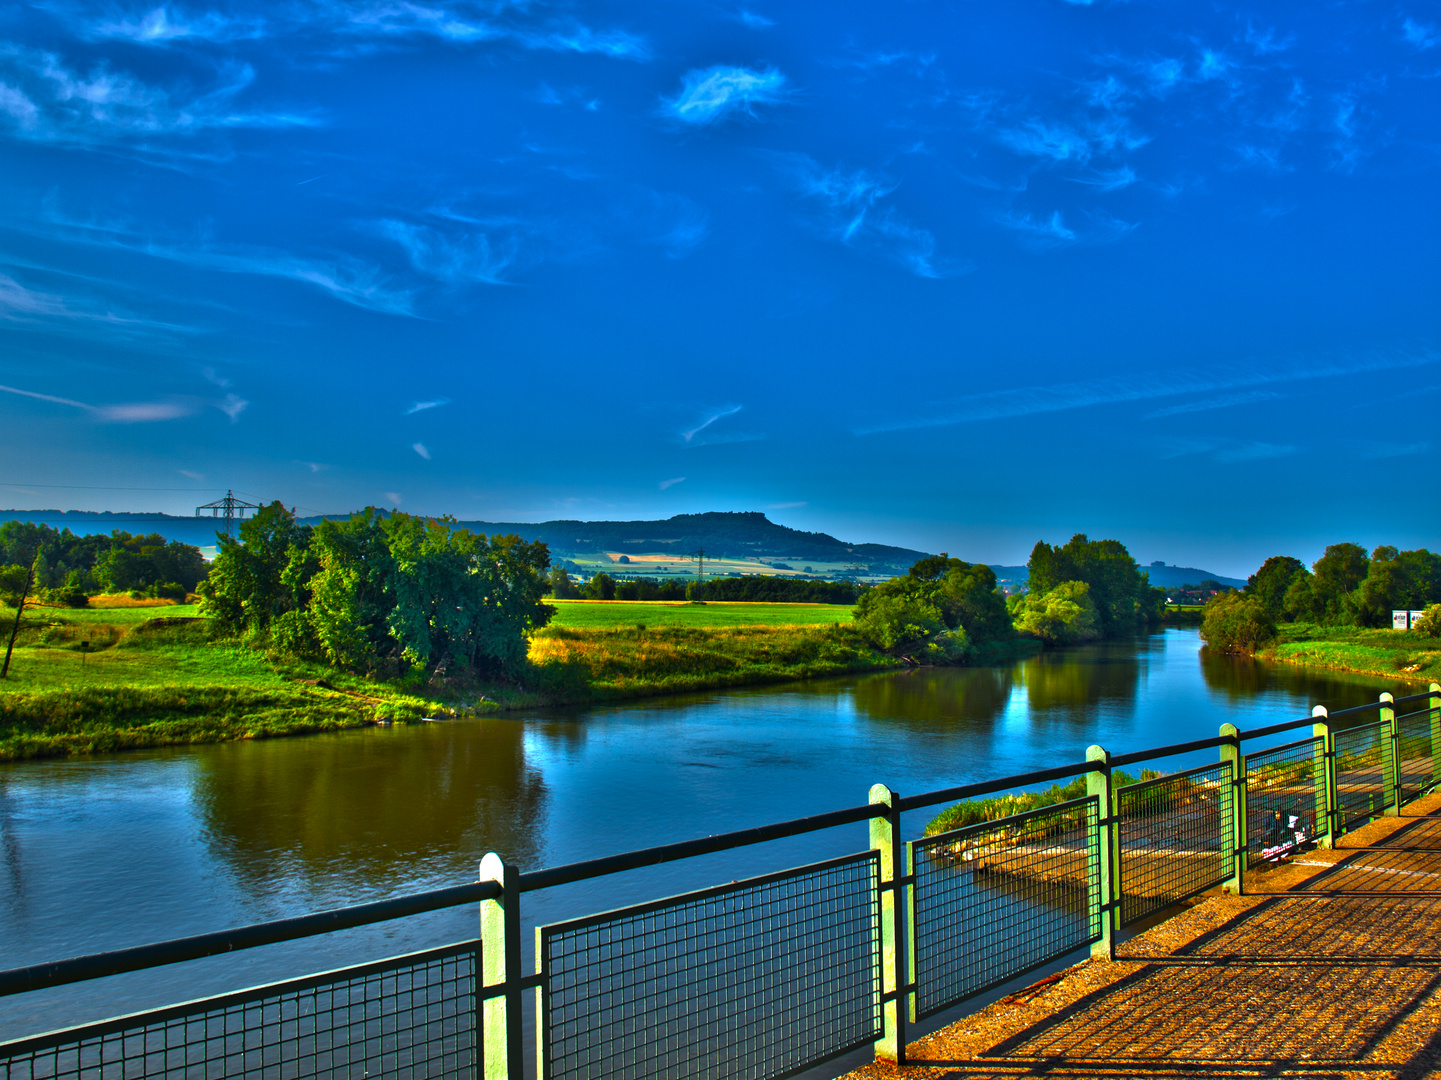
0, 521, 206, 606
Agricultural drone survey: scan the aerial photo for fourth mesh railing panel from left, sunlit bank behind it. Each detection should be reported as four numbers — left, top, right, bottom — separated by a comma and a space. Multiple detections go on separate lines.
1117, 761, 1233, 926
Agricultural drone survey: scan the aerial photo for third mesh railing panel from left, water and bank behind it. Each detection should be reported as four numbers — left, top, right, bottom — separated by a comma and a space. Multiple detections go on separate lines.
908, 797, 1101, 1017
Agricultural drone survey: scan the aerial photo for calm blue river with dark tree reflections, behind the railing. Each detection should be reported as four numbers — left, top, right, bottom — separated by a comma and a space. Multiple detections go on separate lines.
0, 630, 1417, 1038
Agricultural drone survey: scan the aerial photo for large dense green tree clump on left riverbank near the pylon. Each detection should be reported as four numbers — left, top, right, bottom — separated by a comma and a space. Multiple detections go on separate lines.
200, 502, 553, 678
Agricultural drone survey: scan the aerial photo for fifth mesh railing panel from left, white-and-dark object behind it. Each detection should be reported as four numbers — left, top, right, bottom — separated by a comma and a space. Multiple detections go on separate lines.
1246, 738, 1327, 865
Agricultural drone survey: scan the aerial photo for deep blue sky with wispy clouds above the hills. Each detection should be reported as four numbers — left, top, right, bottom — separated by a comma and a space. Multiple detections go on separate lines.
0, 0, 1441, 574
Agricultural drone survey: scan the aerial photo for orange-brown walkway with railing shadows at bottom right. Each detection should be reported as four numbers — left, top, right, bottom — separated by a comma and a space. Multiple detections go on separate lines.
850, 796, 1441, 1080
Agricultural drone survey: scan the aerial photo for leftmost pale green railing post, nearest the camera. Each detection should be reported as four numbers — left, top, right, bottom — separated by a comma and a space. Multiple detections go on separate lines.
477, 852, 525, 1080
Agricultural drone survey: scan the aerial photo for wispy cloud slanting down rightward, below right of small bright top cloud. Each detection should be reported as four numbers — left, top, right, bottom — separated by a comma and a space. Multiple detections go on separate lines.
781, 154, 974, 278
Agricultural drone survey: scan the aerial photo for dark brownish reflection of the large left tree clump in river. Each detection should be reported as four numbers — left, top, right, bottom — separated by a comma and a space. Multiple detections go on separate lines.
196, 720, 546, 887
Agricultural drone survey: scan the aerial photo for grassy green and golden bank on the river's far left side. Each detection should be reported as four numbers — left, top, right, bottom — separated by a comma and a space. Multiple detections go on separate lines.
0, 601, 1040, 761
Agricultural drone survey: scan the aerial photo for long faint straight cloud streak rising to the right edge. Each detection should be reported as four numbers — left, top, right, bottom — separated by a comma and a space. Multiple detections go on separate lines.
855, 352, 1441, 435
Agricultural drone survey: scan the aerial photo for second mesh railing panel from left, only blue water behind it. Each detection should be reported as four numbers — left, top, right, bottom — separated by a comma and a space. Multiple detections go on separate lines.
537, 852, 882, 1080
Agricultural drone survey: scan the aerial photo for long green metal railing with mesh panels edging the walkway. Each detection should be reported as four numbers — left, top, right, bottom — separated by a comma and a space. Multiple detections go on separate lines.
0, 683, 1441, 1080
